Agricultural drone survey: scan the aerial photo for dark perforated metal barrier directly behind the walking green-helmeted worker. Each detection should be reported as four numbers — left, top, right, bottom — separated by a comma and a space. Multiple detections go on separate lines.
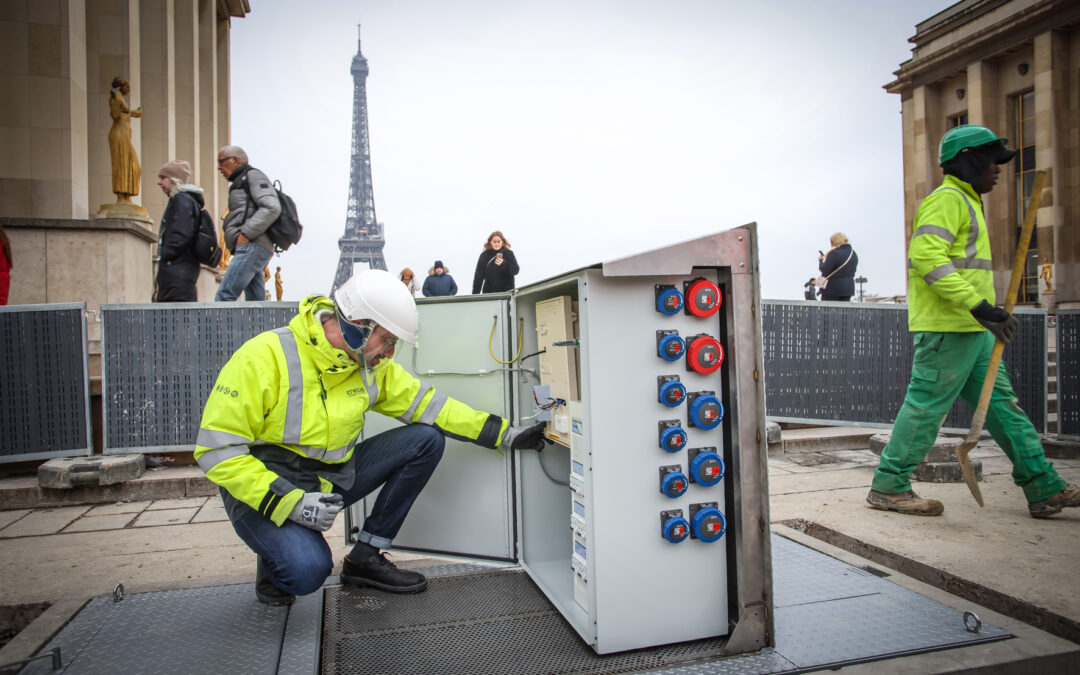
761, 300, 1047, 432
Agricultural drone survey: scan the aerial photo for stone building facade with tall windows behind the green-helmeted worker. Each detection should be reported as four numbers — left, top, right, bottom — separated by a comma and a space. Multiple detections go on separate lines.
885, 0, 1080, 308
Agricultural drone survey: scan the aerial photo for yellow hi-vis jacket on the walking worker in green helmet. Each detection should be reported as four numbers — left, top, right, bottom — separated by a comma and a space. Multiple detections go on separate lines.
907, 176, 995, 333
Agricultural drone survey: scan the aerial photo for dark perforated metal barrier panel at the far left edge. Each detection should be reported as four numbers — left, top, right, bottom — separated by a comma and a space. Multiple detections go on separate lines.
0, 302, 94, 463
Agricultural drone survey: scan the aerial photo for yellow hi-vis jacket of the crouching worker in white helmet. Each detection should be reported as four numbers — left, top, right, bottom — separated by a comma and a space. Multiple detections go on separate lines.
194, 296, 510, 526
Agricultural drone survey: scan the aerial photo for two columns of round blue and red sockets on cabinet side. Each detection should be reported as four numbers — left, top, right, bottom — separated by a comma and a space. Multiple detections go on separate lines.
656, 278, 727, 543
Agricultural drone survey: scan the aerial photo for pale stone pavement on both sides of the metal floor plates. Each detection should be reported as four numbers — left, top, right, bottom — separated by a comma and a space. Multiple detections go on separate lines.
0, 430, 1080, 672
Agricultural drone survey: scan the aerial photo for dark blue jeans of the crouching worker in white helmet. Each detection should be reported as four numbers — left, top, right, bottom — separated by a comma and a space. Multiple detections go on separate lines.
220, 424, 446, 595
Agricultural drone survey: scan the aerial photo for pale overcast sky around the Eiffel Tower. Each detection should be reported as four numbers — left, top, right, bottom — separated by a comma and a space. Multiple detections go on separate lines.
231, 0, 950, 299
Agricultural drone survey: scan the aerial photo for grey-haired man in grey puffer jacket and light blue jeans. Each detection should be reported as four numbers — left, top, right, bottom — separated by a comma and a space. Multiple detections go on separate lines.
214, 146, 282, 301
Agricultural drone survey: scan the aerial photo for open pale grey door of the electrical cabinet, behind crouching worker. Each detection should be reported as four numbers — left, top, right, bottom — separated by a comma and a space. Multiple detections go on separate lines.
347, 295, 518, 561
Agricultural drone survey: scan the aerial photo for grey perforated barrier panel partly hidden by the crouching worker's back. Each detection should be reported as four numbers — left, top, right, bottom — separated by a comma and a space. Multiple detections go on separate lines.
102, 302, 297, 455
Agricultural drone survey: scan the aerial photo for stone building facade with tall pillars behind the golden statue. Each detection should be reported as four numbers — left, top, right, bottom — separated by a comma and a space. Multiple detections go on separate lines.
0, 0, 251, 308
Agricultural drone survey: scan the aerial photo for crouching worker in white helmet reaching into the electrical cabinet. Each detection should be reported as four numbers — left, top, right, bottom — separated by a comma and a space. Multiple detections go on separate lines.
194, 270, 544, 605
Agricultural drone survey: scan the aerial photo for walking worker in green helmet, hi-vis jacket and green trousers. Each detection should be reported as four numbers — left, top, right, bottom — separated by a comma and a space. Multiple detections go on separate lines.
866, 124, 1080, 518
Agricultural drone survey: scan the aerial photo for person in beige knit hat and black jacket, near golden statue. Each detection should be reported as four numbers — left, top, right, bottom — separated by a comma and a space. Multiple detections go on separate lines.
153, 160, 203, 302
